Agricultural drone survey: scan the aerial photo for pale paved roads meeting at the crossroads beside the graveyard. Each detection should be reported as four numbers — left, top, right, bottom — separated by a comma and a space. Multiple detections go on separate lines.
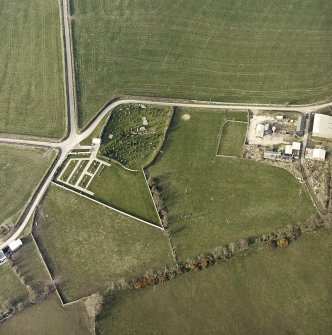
0, 0, 332, 249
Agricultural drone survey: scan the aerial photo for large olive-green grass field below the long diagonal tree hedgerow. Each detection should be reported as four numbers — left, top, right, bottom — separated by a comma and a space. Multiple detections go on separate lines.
97, 231, 332, 335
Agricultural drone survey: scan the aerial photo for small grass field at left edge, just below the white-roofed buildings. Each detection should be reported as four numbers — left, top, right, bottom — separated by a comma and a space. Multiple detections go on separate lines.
0, 262, 29, 316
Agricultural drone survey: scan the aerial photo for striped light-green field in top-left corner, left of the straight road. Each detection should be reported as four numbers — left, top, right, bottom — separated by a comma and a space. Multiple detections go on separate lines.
0, 0, 66, 138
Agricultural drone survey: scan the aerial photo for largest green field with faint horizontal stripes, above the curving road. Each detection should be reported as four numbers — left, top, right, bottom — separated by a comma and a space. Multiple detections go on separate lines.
73, 0, 332, 125
